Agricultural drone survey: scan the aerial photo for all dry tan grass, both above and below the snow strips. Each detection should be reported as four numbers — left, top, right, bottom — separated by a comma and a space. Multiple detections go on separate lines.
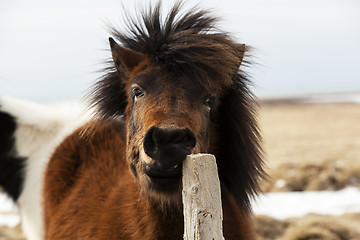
0, 103, 360, 240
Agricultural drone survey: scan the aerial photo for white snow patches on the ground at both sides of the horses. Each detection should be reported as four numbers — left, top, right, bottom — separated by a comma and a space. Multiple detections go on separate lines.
0, 187, 360, 227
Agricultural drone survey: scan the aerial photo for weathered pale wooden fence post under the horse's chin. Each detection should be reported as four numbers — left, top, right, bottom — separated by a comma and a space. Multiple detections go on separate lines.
182, 154, 224, 240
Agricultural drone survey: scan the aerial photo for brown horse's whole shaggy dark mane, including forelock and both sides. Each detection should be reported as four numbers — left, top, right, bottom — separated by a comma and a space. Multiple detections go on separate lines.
91, 2, 265, 212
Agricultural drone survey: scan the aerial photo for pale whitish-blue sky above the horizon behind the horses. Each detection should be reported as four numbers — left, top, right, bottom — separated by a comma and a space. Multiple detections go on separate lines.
0, 0, 360, 102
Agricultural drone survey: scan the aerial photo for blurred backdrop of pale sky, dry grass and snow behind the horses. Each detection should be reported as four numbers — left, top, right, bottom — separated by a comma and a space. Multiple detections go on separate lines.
0, 0, 360, 240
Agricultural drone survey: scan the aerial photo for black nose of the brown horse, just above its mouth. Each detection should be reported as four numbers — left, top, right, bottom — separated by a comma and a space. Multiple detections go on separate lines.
144, 127, 196, 169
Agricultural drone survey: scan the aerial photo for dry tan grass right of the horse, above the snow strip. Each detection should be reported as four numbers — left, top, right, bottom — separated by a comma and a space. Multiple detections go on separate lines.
259, 103, 360, 192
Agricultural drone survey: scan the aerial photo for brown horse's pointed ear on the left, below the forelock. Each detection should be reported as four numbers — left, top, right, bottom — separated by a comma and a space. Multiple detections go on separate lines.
109, 38, 146, 73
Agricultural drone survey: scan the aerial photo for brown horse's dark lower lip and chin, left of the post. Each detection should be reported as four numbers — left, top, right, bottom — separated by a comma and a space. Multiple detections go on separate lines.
145, 163, 182, 192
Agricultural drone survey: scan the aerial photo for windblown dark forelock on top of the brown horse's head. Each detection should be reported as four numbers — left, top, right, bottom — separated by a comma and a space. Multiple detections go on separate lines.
111, 2, 242, 88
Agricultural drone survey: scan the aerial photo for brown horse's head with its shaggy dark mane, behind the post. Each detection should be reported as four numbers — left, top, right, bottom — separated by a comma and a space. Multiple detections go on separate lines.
89, 2, 262, 211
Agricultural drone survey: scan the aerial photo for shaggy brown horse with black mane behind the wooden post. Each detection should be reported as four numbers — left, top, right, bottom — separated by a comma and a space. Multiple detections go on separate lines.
43, 3, 264, 240
